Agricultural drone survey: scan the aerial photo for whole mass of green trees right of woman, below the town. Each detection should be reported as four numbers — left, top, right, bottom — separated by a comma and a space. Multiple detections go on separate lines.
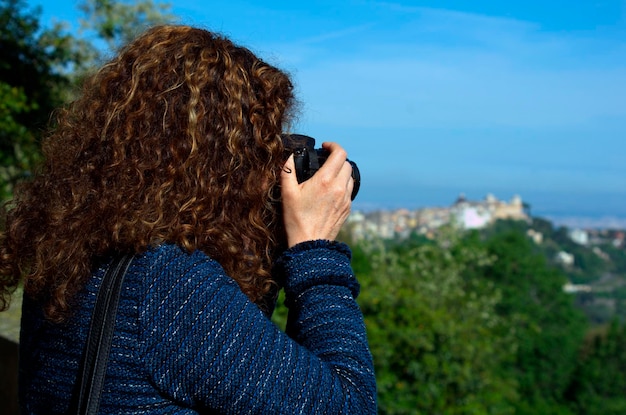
332, 223, 626, 415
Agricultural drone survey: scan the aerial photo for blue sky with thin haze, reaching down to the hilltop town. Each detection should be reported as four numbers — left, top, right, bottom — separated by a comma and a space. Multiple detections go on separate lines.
29, 0, 626, 223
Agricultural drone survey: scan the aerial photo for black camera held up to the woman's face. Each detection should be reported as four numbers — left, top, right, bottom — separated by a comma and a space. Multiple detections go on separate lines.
281, 134, 361, 200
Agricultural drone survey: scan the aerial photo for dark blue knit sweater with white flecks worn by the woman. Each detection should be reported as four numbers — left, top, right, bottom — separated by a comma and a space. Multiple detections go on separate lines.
20, 241, 376, 415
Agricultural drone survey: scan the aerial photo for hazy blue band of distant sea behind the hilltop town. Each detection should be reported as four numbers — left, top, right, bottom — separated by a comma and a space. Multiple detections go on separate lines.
353, 184, 626, 229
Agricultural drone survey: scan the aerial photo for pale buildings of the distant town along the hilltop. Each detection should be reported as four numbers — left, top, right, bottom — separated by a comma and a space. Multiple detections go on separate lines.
348, 194, 530, 239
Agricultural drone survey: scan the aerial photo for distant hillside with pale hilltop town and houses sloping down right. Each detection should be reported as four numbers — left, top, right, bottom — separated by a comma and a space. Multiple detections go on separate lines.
346, 200, 626, 325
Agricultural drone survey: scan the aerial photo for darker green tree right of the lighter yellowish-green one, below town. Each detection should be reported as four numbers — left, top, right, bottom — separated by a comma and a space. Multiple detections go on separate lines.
480, 231, 587, 414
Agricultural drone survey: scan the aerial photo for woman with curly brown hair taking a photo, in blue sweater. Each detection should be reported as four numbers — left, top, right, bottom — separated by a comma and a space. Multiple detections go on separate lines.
0, 26, 376, 414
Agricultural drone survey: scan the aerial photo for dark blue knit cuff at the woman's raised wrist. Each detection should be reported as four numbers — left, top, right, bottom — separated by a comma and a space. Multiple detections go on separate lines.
276, 240, 360, 298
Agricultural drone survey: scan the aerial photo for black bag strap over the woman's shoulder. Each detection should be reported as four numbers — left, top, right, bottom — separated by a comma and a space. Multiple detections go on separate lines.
74, 254, 133, 415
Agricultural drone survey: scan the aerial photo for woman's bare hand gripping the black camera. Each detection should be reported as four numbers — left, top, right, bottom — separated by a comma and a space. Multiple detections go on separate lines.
280, 143, 354, 247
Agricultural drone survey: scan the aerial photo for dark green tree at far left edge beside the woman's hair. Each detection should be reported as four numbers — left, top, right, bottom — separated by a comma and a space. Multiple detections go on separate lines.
0, 0, 72, 200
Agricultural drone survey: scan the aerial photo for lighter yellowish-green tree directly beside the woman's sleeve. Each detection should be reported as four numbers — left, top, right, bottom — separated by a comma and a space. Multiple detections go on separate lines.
353, 228, 516, 414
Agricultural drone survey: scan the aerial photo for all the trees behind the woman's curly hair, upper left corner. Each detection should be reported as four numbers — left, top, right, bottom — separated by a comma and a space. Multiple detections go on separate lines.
0, 0, 175, 201
